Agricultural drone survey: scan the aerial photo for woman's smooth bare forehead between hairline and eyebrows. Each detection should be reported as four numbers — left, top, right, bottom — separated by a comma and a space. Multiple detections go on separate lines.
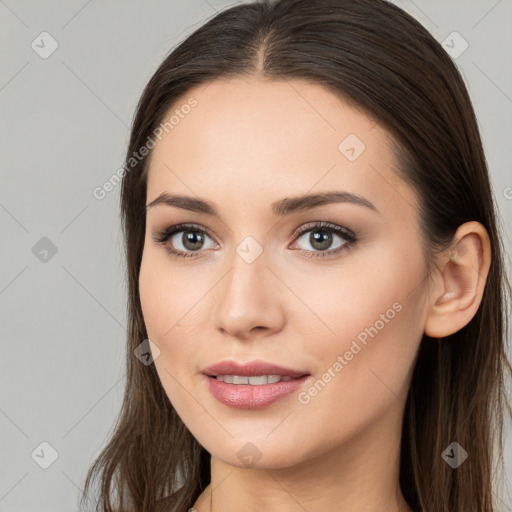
147, 78, 416, 215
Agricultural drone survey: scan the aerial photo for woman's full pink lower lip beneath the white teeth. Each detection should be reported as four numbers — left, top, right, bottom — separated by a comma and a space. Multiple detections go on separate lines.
205, 375, 310, 409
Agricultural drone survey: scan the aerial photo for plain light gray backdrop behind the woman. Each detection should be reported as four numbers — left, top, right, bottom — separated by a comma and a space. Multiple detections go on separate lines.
0, 0, 512, 512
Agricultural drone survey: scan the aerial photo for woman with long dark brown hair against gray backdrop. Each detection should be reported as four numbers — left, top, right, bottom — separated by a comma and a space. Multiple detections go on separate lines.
80, 0, 512, 512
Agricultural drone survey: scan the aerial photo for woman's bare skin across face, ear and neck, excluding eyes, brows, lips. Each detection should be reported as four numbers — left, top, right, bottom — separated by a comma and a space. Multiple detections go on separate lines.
139, 77, 490, 512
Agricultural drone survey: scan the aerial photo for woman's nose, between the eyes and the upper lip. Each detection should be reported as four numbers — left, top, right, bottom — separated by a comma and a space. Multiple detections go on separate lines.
214, 247, 286, 340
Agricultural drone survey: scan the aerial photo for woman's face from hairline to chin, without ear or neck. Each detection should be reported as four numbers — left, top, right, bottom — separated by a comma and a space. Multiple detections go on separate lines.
139, 78, 427, 468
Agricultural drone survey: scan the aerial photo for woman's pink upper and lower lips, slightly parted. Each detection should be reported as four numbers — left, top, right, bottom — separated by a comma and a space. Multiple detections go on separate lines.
203, 361, 311, 409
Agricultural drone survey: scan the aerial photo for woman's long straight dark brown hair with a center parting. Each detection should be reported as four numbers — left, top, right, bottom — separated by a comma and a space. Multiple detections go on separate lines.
83, 0, 512, 512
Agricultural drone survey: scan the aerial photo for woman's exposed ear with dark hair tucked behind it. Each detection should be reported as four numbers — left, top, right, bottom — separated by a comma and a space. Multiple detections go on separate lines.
425, 221, 491, 338
